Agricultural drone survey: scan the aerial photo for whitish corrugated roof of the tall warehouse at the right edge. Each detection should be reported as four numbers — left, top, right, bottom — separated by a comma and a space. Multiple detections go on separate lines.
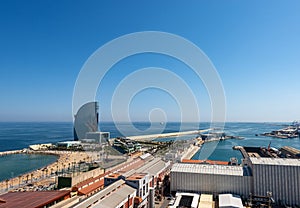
250, 157, 300, 166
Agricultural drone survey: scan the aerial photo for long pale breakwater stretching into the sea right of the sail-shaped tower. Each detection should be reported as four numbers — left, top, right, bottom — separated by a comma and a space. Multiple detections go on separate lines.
126, 129, 211, 141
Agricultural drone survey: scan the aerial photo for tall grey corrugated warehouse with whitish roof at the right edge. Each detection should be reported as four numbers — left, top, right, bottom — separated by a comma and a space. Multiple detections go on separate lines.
249, 157, 300, 205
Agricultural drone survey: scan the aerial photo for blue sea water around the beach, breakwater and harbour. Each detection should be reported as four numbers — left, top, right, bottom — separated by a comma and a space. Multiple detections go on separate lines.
0, 122, 300, 181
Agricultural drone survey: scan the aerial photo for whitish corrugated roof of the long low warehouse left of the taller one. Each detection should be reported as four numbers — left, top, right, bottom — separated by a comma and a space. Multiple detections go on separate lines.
171, 163, 243, 176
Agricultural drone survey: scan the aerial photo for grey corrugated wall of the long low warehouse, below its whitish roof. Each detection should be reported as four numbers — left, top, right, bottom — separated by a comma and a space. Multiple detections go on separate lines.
171, 172, 253, 197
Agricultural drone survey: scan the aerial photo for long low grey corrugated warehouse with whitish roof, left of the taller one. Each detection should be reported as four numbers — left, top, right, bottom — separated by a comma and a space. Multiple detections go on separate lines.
170, 163, 253, 197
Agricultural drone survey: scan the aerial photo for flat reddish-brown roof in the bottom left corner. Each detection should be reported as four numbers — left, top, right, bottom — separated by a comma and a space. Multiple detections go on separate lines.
0, 191, 70, 208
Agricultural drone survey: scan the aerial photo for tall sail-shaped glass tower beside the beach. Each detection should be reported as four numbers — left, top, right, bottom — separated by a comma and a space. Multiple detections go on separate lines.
74, 102, 99, 141
